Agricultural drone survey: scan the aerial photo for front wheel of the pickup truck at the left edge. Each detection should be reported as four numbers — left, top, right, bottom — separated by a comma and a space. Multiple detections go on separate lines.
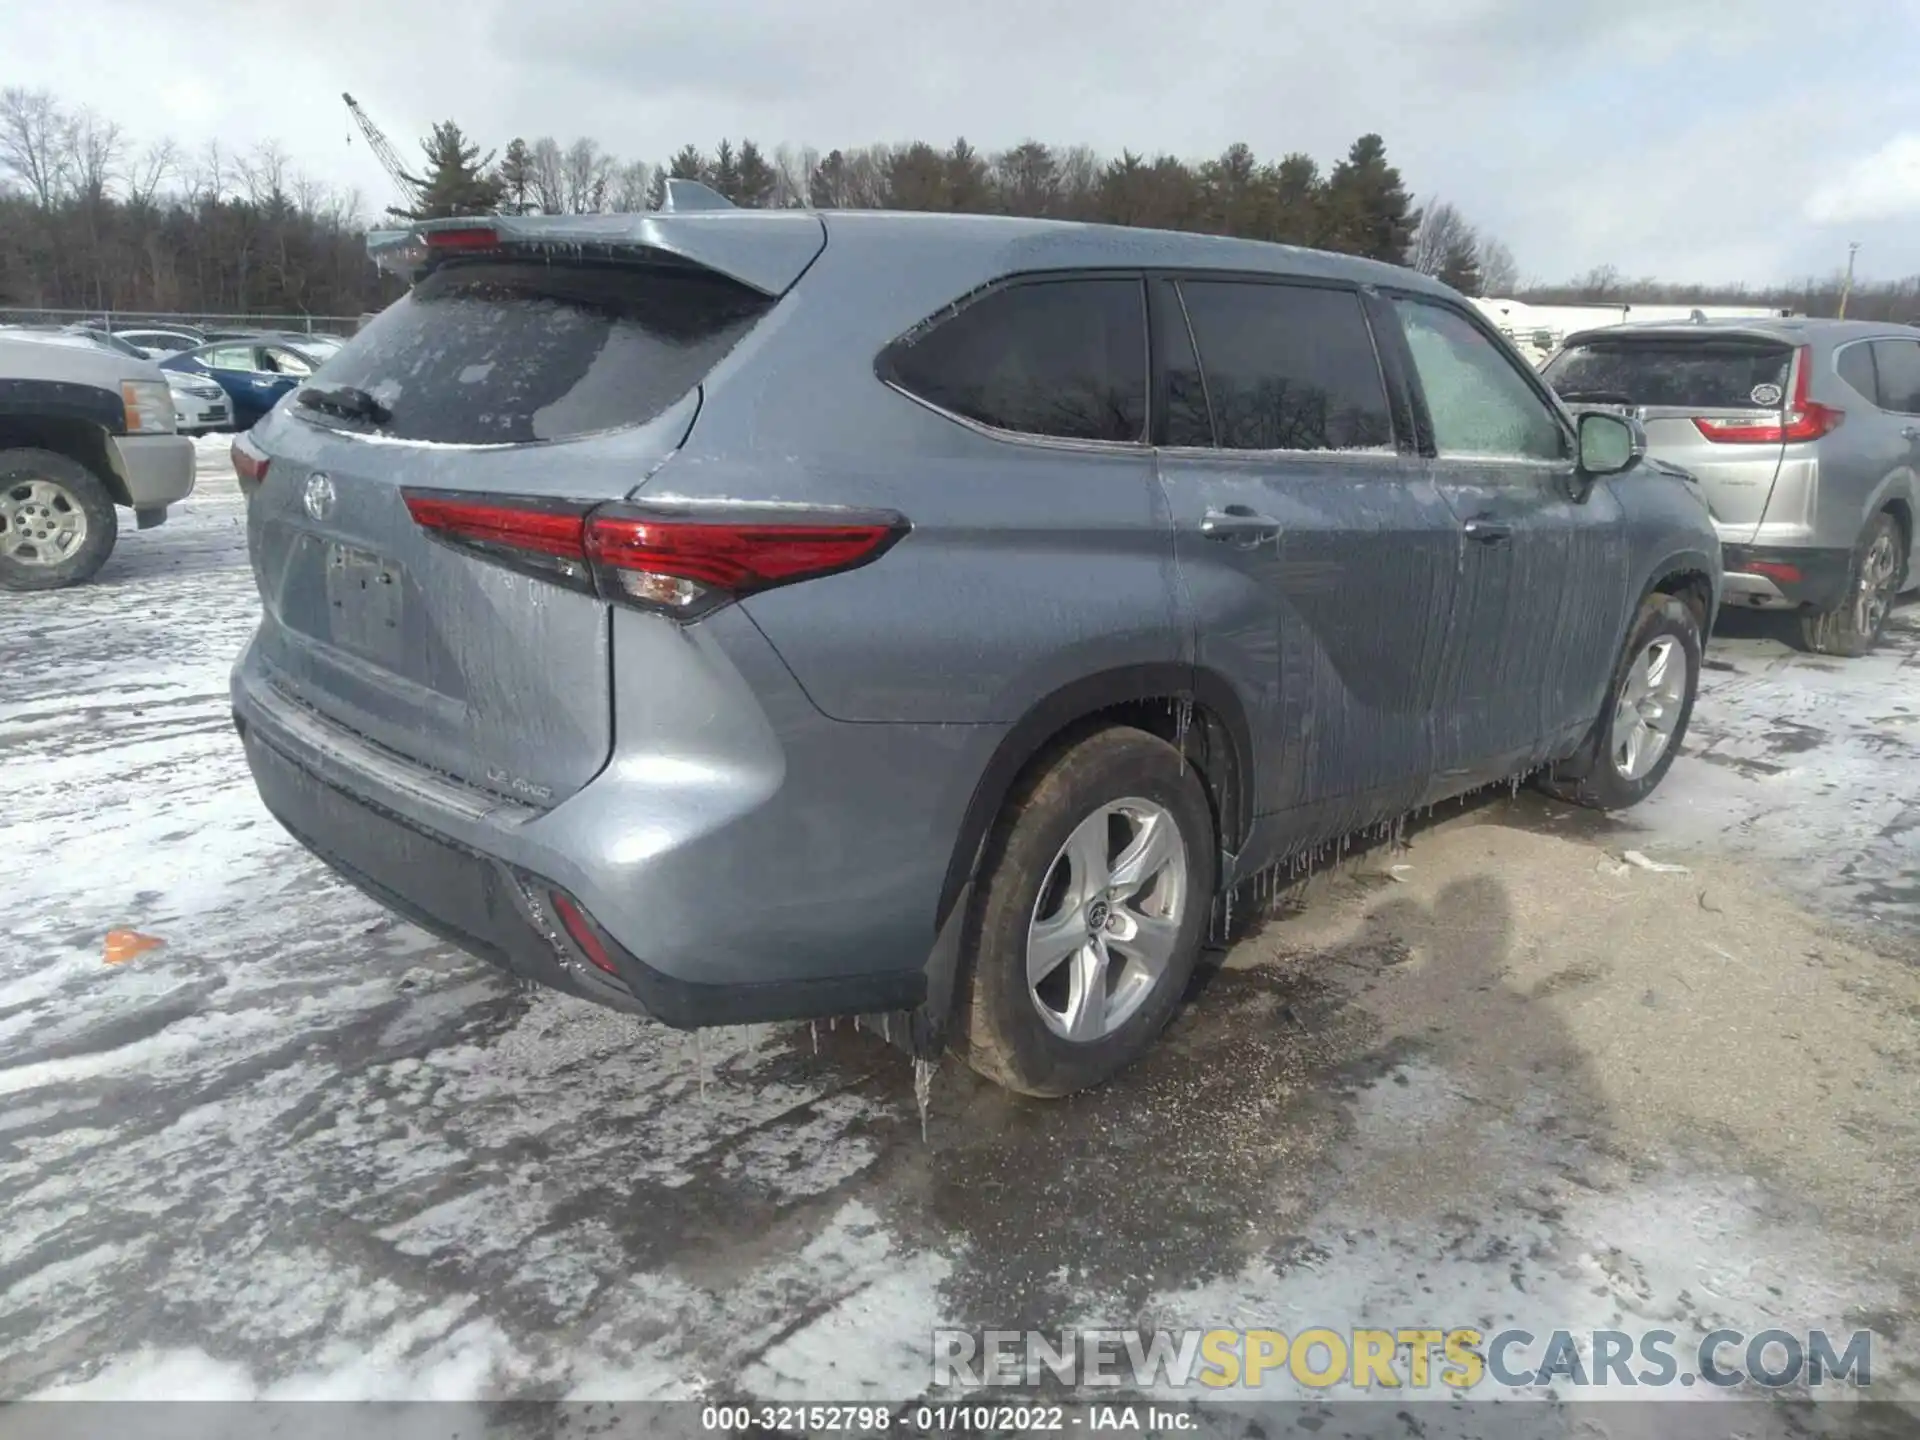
0, 449, 119, 589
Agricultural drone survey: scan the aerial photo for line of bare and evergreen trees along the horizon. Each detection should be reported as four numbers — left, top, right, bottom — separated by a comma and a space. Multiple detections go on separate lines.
11, 88, 1920, 330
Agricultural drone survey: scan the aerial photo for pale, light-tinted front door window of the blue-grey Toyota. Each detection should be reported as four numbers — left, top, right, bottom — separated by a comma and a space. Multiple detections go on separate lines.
1394, 296, 1567, 461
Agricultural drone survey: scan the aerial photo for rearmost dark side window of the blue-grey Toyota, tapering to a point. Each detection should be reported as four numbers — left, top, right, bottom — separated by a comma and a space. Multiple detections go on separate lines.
881, 278, 1146, 442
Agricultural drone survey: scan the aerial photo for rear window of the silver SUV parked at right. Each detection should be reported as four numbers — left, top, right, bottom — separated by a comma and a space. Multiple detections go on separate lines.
1546, 340, 1793, 409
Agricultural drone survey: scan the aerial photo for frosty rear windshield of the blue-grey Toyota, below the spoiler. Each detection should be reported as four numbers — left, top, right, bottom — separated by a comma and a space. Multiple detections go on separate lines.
300, 261, 774, 444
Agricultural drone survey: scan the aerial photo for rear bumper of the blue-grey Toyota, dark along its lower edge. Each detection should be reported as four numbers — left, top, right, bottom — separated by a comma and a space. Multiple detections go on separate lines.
232, 616, 966, 1029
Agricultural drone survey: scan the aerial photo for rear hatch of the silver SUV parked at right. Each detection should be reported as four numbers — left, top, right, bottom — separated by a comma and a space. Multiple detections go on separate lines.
1542, 328, 1797, 543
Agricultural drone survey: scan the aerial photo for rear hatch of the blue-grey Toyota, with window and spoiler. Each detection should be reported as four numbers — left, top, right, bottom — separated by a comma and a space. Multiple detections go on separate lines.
236, 215, 824, 804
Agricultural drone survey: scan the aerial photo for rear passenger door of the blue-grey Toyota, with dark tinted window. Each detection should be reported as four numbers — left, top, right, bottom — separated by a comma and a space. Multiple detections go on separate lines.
1154, 276, 1459, 844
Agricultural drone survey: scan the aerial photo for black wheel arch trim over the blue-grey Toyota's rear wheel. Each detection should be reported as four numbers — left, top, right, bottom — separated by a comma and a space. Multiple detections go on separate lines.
935, 662, 1254, 927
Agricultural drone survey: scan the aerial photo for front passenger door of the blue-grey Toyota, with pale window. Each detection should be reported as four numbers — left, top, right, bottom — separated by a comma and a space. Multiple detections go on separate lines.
1394, 296, 1634, 791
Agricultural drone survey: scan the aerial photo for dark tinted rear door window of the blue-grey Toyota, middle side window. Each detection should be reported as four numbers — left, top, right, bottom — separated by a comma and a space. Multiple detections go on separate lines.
1169, 280, 1394, 449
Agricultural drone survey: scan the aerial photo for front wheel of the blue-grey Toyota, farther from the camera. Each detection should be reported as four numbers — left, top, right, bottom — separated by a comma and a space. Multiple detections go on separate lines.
1540, 593, 1701, 810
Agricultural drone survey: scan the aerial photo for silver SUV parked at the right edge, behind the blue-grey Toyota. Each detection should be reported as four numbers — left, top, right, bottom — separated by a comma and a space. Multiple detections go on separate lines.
1546, 319, 1920, 655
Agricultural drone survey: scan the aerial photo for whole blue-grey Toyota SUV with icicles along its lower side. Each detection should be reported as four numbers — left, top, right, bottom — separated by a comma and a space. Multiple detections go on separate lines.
232, 200, 1720, 1094
